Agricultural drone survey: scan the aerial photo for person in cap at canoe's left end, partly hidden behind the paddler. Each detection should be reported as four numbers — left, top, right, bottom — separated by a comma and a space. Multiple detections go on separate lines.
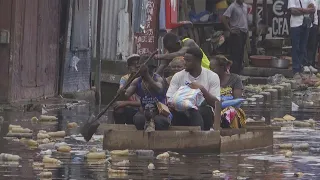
113, 54, 141, 124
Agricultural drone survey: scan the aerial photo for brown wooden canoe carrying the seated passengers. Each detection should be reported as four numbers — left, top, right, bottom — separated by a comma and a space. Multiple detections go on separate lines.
98, 124, 275, 153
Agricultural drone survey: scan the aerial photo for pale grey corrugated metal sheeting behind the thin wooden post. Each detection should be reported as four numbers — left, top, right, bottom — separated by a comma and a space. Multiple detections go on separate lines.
91, 0, 127, 60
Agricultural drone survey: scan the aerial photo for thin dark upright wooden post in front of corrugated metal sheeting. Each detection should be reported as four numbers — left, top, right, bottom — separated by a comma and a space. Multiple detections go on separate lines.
95, 0, 103, 105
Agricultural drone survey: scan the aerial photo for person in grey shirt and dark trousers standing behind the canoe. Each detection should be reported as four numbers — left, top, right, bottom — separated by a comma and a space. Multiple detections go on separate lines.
221, 0, 248, 74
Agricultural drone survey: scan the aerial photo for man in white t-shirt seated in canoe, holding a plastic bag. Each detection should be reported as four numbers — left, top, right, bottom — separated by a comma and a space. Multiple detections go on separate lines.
167, 47, 220, 130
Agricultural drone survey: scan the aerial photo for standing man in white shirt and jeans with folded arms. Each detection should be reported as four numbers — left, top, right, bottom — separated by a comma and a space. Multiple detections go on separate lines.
288, 0, 315, 79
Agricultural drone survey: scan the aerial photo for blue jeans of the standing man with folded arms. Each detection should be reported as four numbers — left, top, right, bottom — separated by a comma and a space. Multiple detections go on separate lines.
290, 26, 310, 74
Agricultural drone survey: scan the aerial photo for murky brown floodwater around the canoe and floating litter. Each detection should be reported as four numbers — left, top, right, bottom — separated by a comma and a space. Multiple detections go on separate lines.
0, 93, 320, 180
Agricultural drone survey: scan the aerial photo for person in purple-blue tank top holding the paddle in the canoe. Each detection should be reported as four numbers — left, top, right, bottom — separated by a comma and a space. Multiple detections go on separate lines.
125, 56, 171, 132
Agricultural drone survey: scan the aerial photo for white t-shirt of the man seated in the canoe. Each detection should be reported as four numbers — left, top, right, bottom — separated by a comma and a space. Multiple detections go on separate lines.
167, 68, 220, 100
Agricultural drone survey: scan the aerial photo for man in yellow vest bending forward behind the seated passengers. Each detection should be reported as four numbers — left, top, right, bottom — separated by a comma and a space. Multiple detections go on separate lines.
155, 33, 210, 74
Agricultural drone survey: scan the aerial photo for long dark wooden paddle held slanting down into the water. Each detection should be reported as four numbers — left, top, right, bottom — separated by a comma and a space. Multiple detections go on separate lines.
80, 50, 158, 141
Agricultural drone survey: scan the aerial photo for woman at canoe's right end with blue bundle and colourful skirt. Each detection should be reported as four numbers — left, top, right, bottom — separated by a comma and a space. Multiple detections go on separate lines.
210, 55, 246, 128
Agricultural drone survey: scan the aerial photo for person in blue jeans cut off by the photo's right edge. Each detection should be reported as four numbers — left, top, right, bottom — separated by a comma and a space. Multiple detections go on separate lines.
304, 0, 320, 73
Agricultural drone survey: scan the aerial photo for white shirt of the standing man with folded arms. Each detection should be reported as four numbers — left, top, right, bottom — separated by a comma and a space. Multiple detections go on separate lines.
288, 0, 316, 27
